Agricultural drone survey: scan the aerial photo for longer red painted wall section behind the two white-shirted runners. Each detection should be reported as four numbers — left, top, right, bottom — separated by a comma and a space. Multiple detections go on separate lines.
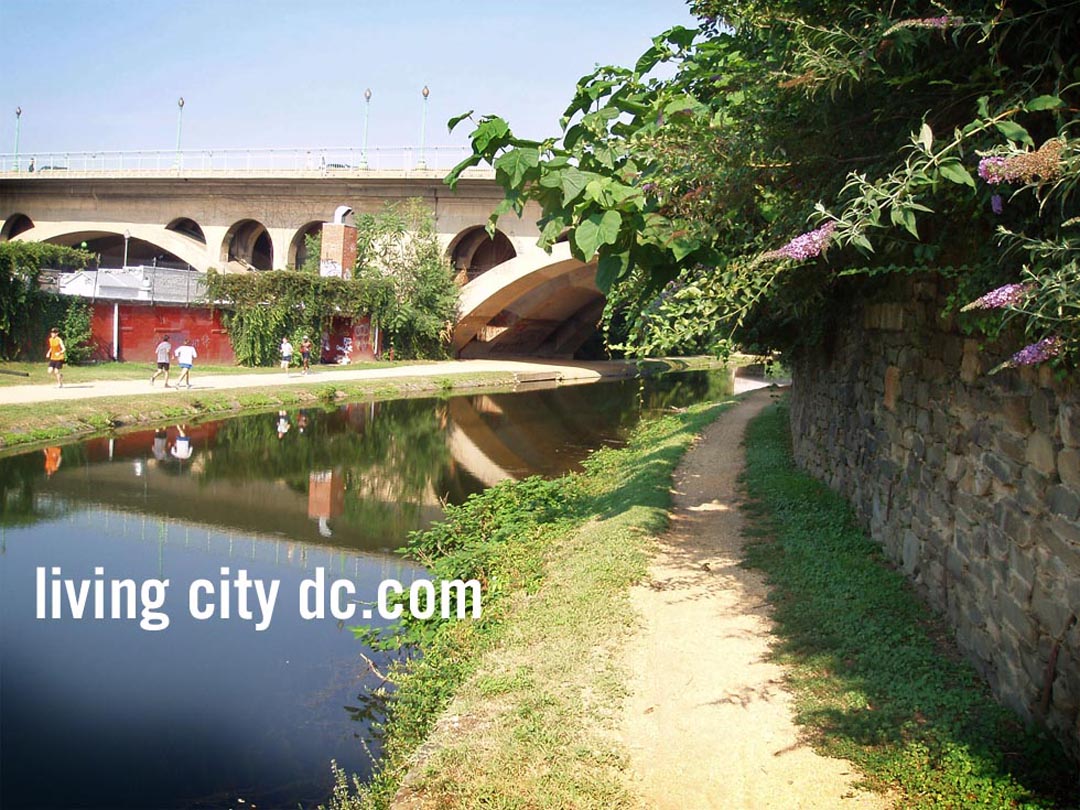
91, 301, 237, 365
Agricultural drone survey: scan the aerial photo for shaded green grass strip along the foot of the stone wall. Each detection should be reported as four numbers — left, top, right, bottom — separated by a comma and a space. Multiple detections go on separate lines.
744, 405, 1078, 809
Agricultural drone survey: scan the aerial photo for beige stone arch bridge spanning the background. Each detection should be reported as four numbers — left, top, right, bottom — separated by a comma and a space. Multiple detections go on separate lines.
0, 170, 604, 357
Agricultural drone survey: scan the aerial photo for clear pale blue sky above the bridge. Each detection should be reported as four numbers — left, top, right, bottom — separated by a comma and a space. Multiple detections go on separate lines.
0, 0, 696, 156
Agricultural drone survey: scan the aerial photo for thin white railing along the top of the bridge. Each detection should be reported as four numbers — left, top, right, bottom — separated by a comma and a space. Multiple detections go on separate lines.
0, 146, 486, 177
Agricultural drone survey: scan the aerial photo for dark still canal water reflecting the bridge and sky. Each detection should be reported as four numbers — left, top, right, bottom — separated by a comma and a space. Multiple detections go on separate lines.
0, 372, 731, 810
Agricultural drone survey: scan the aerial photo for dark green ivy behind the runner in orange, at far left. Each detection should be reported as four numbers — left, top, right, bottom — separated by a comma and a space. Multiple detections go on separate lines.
0, 242, 95, 363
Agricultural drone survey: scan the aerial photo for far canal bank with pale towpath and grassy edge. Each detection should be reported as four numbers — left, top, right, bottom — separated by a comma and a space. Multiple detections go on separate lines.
0, 357, 738, 454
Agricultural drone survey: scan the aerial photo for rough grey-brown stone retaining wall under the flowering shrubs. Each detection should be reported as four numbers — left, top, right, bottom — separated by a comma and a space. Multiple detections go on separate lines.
791, 273, 1080, 758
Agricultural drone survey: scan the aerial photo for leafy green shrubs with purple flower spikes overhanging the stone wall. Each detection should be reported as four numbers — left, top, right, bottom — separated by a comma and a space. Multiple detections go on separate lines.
449, 0, 1080, 373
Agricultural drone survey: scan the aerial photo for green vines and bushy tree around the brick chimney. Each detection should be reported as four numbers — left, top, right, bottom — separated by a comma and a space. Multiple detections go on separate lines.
206, 200, 457, 366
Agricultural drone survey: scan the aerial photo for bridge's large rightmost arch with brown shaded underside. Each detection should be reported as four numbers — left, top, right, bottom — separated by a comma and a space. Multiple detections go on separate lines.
454, 252, 605, 357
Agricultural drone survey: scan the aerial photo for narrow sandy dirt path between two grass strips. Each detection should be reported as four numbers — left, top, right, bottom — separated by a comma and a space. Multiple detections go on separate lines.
622, 391, 888, 810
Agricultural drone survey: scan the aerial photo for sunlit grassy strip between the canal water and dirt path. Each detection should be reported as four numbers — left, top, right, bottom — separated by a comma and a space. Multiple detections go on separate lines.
332, 405, 734, 810
